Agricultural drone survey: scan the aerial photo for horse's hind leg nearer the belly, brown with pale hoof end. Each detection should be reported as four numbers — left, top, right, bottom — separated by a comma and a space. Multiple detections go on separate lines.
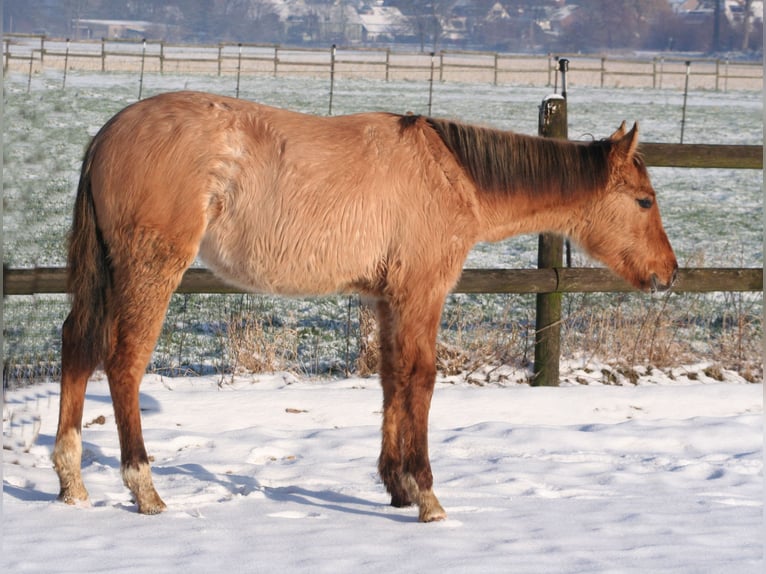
105, 236, 192, 514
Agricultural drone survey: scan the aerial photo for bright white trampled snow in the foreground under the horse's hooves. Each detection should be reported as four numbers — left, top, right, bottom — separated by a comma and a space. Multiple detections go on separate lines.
0, 367, 763, 574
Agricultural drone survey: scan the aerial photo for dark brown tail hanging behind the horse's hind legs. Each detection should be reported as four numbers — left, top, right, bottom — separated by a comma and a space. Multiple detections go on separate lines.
67, 140, 112, 368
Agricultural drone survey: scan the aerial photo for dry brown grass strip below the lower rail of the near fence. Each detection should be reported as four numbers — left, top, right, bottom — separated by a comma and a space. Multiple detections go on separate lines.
226, 293, 763, 383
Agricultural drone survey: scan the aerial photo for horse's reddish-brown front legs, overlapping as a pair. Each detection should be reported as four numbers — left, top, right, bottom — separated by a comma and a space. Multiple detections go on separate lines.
380, 299, 447, 522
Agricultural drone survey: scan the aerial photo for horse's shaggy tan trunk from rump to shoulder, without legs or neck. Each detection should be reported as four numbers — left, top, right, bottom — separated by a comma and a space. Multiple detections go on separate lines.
86, 92, 450, 300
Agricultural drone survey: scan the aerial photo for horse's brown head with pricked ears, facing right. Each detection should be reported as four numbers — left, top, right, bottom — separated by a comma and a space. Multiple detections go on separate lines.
574, 122, 678, 291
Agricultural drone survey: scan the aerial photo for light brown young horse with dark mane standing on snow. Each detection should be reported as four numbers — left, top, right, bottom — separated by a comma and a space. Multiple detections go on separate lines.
52, 92, 678, 522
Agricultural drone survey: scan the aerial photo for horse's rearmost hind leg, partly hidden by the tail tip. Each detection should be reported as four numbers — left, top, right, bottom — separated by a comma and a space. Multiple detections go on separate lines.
51, 315, 97, 504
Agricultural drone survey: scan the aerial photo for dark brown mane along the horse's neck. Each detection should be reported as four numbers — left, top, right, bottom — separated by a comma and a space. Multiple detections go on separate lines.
400, 116, 612, 199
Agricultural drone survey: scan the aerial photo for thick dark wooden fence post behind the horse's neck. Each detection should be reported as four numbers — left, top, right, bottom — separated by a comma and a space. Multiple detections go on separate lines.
531, 63, 567, 386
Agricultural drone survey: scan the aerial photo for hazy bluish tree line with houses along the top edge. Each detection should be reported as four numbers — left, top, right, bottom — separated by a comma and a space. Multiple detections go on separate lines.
3, 0, 763, 53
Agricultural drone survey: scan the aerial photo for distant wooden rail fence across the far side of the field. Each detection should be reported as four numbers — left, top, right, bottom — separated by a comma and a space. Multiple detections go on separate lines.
3, 34, 763, 90
